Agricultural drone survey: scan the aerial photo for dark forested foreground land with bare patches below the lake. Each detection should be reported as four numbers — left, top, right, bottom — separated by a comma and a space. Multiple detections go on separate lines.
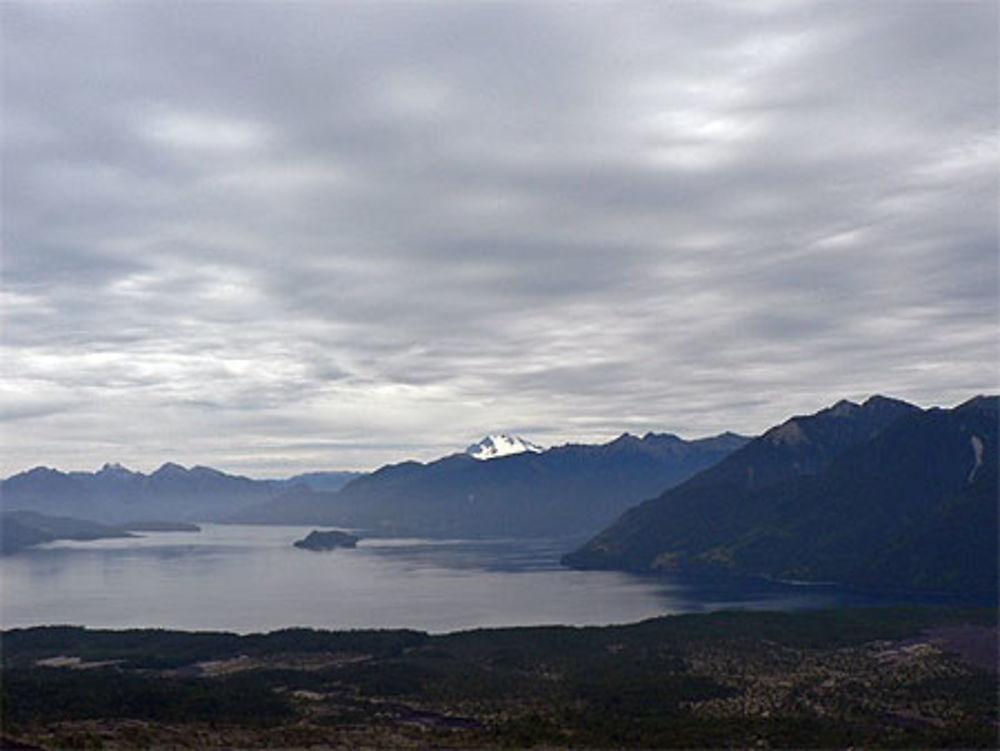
3, 608, 997, 749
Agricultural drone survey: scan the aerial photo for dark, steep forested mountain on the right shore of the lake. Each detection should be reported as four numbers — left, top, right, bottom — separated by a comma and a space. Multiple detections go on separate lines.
564, 397, 997, 592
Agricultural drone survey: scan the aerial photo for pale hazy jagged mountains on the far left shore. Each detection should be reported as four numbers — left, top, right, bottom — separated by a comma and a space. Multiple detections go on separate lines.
0, 462, 277, 523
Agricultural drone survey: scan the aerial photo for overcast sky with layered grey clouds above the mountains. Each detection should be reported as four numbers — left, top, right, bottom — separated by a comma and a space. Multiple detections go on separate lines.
0, 0, 1000, 476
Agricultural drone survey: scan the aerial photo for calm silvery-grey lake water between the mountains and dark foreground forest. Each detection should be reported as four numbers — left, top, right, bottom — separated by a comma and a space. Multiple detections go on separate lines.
0, 524, 952, 632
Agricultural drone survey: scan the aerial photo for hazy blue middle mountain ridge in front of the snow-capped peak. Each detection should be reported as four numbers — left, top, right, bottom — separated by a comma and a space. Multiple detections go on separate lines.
233, 433, 748, 536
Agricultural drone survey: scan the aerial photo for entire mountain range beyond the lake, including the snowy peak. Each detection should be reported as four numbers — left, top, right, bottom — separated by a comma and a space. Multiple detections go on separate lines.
0, 396, 998, 597
